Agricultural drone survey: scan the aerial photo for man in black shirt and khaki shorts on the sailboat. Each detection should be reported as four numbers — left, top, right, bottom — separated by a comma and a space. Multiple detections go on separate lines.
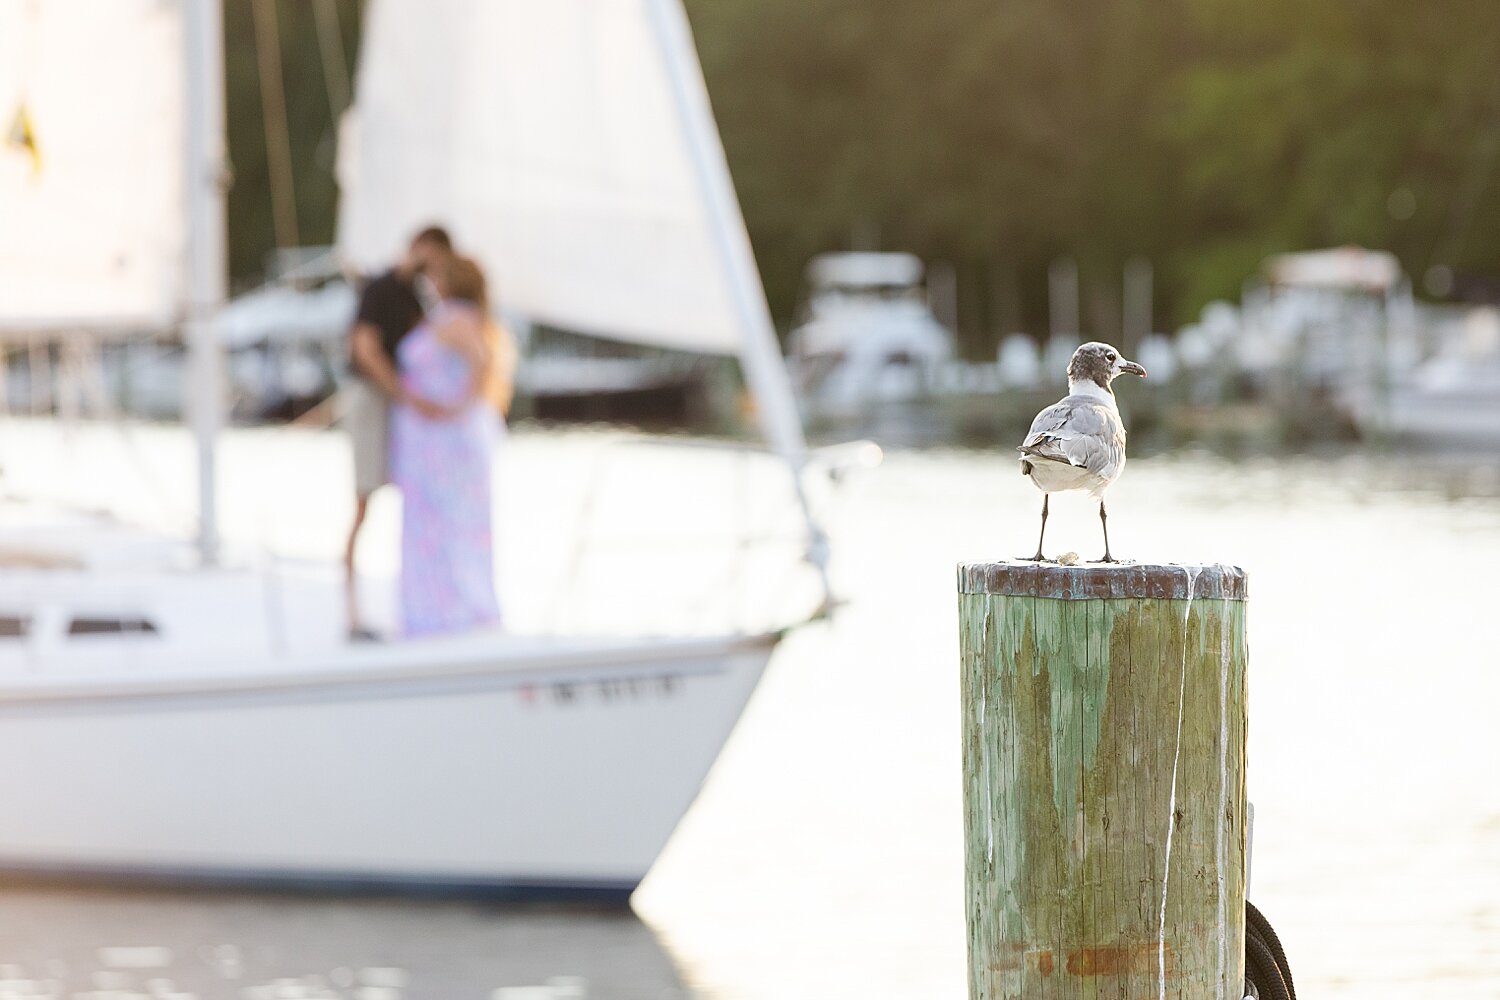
344, 226, 453, 639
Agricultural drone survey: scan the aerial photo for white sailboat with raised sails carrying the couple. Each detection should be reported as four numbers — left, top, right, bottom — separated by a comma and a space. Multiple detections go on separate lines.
0, 0, 827, 900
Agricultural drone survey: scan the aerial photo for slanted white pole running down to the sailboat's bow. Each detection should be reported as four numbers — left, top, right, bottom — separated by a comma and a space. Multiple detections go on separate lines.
645, 0, 833, 601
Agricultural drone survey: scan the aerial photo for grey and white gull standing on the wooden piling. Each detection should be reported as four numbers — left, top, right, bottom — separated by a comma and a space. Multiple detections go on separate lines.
1017, 340, 1146, 562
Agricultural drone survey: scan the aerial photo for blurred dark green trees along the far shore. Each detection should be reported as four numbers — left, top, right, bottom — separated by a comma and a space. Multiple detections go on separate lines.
225, 0, 1500, 357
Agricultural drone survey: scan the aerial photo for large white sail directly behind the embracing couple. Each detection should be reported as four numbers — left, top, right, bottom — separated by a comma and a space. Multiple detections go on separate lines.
339, 0, 746, 354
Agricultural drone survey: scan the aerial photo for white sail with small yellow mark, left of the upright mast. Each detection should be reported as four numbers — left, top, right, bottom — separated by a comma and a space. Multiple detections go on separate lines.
0, 0, 186, 331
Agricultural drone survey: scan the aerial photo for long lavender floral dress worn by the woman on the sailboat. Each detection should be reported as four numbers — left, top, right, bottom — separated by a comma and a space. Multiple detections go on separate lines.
390, 300, 503, 636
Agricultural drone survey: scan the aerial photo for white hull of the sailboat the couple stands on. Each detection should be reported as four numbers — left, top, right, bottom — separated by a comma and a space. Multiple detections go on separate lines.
0, 636, 776, 897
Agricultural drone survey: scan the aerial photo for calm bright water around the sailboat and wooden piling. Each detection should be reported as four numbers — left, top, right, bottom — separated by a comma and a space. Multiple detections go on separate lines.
0, 423, 1500, 1000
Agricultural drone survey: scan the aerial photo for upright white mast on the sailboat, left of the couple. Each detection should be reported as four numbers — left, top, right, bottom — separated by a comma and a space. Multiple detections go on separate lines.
183, 0, 228, 565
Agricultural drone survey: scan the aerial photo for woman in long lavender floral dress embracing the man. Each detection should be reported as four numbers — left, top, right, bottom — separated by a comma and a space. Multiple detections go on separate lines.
390, 258, 513, 636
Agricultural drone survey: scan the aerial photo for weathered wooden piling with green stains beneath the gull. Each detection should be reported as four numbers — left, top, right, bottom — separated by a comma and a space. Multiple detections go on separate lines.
959, 562, 1247, 1000
